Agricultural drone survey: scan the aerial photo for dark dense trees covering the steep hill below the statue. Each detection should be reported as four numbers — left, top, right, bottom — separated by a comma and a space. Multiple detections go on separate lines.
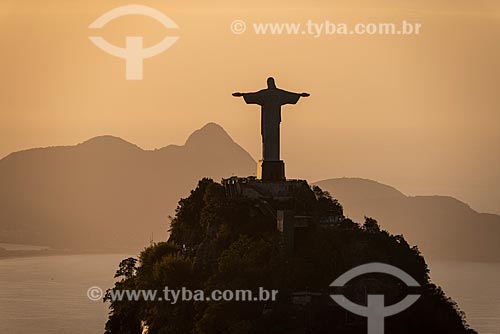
105, 179, 475, 334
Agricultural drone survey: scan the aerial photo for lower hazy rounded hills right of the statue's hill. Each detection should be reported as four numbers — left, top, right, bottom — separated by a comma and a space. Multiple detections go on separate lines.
315, 178, 500, 261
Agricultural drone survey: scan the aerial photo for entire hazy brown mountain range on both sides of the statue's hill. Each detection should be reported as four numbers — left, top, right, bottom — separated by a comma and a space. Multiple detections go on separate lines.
0, 123, 500, 260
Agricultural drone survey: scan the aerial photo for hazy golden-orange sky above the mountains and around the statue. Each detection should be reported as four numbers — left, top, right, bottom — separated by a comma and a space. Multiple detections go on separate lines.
0, 0, 500, 213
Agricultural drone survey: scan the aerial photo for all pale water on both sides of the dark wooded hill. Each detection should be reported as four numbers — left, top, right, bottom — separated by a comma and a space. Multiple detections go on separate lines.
0, 254, 500, 334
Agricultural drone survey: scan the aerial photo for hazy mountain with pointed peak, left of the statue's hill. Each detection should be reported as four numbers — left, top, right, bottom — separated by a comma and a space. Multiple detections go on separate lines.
0, 123, 255, 248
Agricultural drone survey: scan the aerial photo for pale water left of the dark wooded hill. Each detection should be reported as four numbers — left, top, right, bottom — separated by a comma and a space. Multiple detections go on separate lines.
0, 254, 128, 334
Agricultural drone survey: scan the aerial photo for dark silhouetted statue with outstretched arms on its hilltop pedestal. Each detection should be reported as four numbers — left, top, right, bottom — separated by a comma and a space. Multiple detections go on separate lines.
233, 78, 309, 180
